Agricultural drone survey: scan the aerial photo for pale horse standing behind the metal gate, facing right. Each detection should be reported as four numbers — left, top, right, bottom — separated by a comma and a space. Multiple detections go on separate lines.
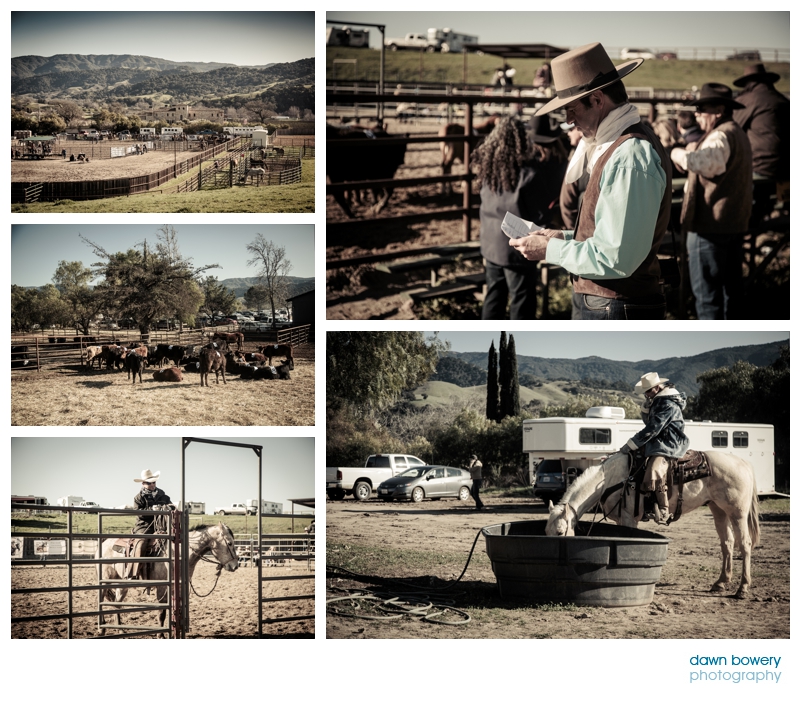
98, 522, 239, 631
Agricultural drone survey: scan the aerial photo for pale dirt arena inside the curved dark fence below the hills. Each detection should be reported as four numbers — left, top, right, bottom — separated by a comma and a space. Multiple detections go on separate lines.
11, 145, 199, 183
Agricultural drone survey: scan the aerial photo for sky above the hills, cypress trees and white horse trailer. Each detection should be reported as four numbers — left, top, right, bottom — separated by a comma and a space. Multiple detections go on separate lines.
439, 331, 790, 361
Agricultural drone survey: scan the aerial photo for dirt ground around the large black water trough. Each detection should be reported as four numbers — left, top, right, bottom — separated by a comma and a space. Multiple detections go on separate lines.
326, 497, 790, 639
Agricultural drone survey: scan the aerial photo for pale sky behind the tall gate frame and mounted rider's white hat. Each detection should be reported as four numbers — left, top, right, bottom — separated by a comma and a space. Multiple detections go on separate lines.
11, 436, 315, 512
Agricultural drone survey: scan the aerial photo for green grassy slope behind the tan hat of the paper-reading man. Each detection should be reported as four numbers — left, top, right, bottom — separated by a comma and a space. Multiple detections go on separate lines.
325, 47, 790, 92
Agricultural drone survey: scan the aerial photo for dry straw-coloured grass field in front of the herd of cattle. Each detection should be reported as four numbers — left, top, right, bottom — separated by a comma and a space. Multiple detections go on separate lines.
11, 344, 314, 426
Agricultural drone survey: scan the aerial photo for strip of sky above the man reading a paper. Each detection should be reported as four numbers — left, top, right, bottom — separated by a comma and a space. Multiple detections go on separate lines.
326, 11, 790, 52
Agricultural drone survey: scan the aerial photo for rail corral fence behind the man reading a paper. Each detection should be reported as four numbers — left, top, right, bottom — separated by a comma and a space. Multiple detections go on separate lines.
326, 91, 789, 317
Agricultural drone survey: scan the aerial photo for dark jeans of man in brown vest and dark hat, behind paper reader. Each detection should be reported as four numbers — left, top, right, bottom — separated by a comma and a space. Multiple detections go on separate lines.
687, 232, 743, 319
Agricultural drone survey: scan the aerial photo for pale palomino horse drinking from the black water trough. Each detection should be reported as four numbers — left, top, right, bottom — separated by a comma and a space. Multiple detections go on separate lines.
545, 451, 759, 599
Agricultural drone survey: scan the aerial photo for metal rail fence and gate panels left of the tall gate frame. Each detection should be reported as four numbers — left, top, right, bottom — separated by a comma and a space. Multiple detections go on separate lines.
11, 502, 181, 639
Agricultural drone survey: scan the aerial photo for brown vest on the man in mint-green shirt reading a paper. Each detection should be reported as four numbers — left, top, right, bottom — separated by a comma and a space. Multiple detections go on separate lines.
573, 123, 672, 300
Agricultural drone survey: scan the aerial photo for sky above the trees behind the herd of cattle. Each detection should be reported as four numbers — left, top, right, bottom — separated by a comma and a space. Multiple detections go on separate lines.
11, 224, 314, 287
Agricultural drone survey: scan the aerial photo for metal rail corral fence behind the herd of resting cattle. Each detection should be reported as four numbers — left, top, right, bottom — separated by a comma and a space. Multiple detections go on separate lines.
11, 324, 311, 371
